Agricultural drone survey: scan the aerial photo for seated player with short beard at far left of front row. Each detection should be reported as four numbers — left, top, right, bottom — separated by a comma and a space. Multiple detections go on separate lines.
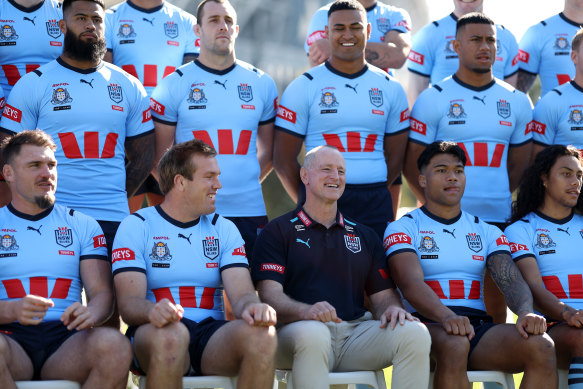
0, 131, 131, 389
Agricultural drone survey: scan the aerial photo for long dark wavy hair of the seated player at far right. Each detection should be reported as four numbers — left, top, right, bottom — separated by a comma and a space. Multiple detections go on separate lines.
510, 145, 583, 223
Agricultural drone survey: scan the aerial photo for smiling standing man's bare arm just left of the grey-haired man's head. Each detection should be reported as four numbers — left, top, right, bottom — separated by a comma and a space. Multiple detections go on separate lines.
273, 131, 303, 202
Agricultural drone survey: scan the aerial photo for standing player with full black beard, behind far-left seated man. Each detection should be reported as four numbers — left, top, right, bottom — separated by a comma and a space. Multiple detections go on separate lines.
0, 0, 154, 264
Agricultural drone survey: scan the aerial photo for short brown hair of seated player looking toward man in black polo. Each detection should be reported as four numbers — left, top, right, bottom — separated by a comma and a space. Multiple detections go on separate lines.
158, 139, 217, 194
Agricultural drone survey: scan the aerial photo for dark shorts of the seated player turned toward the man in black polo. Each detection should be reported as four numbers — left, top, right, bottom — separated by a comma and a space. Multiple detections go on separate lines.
126, 317, 228, 375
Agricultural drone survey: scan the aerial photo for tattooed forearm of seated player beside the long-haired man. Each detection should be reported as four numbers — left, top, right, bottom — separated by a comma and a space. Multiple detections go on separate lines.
487, 253, 533, 314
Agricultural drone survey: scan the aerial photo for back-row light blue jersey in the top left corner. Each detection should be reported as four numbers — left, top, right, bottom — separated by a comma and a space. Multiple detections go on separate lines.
0, 0, 63, 95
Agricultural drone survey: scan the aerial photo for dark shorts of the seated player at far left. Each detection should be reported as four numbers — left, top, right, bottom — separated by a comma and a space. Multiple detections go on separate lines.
0, 321, 77, 380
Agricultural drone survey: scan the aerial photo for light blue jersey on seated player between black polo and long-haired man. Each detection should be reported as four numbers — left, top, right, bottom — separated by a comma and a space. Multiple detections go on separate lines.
383, 207, 510, 311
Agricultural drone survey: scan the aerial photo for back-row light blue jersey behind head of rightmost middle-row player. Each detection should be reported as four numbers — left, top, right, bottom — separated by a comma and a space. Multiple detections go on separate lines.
407, 13, 518, 84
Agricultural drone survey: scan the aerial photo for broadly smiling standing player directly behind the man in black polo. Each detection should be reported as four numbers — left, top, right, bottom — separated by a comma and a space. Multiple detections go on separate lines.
274, 0, 409, 237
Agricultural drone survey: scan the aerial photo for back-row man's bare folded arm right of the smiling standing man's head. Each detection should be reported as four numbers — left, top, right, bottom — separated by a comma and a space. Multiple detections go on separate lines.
365, 30, 411, 69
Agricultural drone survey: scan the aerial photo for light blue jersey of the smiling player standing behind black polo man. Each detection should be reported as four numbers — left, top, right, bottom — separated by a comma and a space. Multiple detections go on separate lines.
275, 62, 409, 184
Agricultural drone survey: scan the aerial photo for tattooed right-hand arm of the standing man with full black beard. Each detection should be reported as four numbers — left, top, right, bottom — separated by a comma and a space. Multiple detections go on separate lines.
125, 132, 154, 198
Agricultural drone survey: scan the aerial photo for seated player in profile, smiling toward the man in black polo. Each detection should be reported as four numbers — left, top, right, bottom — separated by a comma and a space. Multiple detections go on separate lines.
113, 139, 276, 389
